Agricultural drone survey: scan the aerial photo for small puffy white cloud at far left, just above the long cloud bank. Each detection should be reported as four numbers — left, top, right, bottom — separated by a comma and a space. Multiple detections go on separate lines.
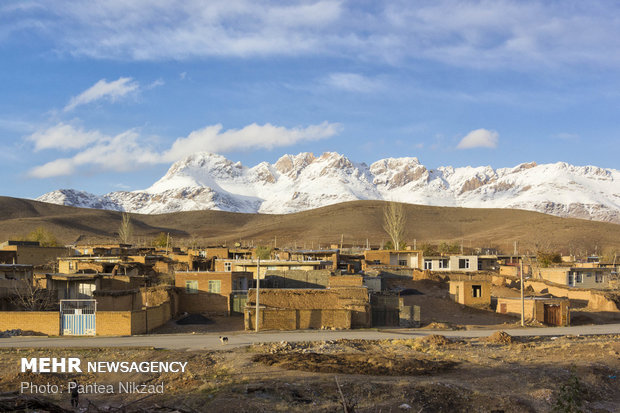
26, 122, 103, 151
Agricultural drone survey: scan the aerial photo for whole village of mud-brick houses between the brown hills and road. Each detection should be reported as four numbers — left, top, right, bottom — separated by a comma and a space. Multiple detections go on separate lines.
0, 227, 620, 336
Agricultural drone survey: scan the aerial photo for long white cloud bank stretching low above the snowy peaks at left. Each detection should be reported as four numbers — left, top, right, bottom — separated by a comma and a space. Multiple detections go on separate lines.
28, 122, 340, 178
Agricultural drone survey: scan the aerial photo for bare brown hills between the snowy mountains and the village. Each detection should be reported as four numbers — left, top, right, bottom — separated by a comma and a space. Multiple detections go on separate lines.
0, 197, 620, 253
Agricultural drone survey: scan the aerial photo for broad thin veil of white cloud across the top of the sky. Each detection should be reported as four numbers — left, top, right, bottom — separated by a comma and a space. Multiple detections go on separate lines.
0, 0, 620, 70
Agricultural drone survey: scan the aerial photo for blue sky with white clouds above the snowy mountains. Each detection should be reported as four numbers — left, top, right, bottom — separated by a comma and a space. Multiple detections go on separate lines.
0, 0, 620, 198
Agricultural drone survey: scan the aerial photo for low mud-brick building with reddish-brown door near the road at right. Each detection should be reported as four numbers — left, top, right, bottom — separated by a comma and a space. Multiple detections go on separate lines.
495, 297, 570, 326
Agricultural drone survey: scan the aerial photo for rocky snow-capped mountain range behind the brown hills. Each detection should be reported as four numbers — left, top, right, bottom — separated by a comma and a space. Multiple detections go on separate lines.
37, 152, 620, 223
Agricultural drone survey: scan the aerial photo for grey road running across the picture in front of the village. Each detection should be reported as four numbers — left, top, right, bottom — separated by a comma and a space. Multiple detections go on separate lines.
0, 324, 620, 350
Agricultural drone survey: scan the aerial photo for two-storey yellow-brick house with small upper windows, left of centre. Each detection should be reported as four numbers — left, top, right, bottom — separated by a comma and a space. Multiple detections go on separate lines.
174, 271, 253, 315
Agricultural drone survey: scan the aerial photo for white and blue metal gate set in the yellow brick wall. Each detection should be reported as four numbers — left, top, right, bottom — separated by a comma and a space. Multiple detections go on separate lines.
60, 300, 97, 336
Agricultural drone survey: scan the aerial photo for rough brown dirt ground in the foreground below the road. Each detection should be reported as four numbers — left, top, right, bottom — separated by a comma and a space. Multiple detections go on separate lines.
0, 333, 620, 413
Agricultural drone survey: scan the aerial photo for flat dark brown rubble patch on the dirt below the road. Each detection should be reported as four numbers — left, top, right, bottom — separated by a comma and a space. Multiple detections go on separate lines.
252, 352, 456, 376
